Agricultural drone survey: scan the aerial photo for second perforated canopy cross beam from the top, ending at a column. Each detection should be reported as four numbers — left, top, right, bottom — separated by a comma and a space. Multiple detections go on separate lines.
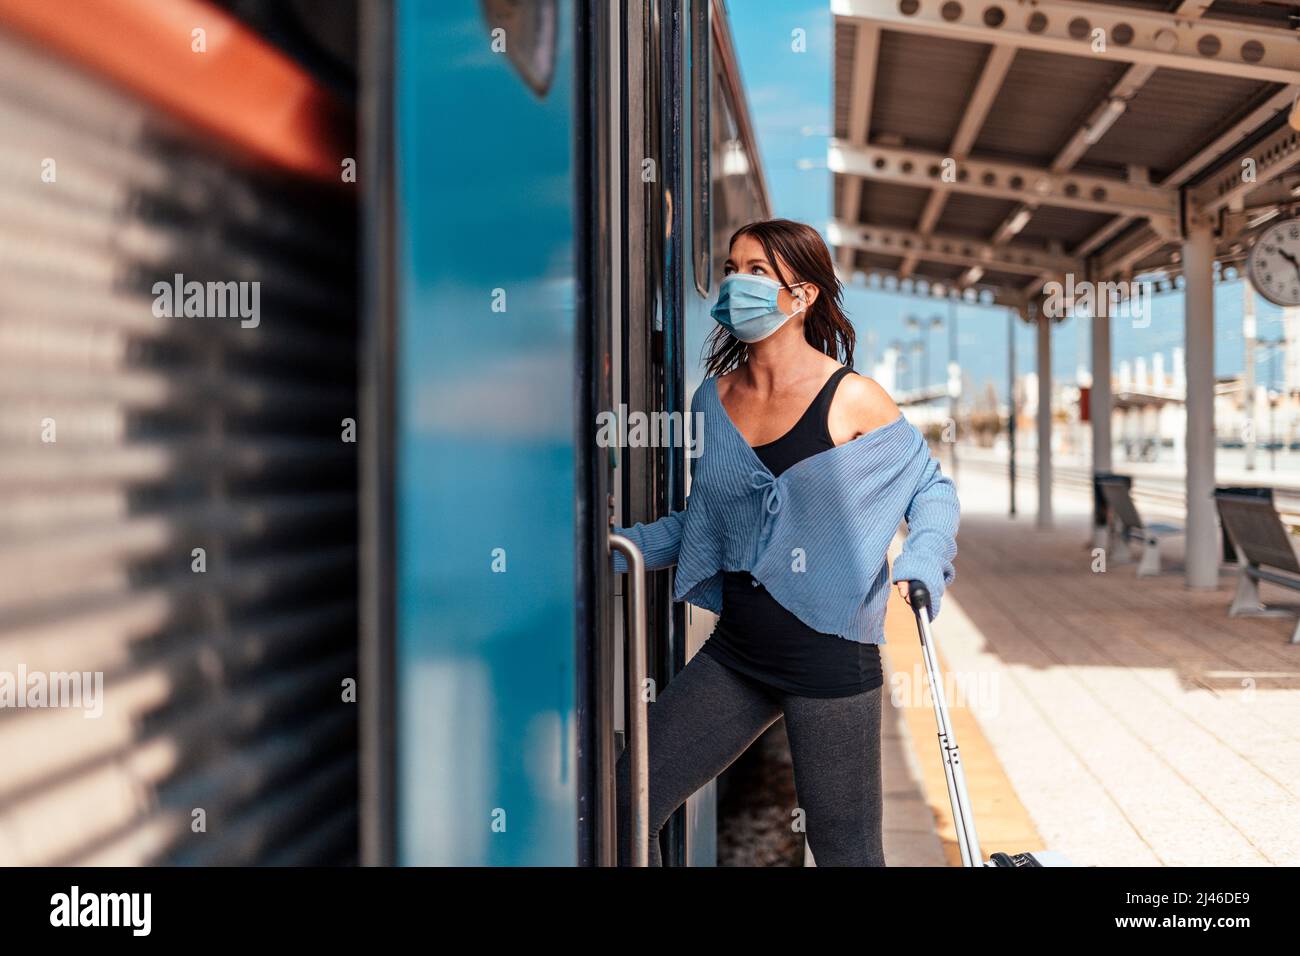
827, 139, 1178, 216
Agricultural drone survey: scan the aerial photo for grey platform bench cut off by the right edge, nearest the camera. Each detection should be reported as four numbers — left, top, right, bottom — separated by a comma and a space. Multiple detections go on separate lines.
1214, 492, 1300, 644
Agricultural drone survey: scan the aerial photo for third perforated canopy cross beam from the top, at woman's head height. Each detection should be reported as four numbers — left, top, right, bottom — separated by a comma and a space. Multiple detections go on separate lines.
827, 221, 1083, 278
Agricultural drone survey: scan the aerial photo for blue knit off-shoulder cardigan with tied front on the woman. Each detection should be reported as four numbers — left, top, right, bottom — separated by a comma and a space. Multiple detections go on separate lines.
615, 377, 958, 644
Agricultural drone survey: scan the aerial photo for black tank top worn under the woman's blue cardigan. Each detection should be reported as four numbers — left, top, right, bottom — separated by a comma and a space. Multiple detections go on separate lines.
699, 368, 884, 697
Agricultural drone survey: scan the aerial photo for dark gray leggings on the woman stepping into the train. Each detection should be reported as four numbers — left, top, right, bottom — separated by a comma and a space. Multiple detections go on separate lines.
618, 654, 885, 866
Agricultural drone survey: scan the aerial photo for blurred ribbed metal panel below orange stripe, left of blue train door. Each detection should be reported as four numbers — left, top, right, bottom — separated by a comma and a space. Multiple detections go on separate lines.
0, 24, 358, 865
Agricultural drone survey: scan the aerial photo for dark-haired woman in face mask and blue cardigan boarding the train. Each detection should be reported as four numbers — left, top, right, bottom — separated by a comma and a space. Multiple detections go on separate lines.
615, 220, 958, 866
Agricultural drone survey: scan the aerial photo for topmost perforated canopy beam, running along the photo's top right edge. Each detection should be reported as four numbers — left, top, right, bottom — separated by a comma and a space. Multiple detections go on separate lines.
831, 0, 1300, 83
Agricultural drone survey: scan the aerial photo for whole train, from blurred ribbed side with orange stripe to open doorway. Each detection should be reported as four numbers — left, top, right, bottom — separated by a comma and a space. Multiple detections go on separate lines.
0, 0, 771, 866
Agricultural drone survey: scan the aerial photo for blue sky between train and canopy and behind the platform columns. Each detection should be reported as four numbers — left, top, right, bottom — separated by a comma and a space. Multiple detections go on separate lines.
727, 0, 1282, 395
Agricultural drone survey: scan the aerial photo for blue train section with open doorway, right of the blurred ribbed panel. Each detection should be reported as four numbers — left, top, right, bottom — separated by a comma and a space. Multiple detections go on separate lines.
360, 0, 768, 865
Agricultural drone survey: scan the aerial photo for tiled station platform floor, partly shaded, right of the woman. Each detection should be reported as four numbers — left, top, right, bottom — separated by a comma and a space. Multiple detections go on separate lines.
884, 467, 1300, 866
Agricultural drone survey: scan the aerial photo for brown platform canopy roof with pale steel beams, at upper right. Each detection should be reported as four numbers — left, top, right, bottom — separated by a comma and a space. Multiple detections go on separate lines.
828, 0, 1300, 307
